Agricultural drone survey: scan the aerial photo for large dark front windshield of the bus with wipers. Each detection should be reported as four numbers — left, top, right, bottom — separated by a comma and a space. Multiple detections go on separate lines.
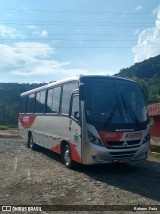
82, 78, 147, 124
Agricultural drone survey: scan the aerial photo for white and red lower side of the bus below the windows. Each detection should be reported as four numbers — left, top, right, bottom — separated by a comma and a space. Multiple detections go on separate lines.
19, 114, 81, 163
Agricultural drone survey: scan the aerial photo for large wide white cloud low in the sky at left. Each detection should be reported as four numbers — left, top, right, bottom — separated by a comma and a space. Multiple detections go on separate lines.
0, 42, 89, 77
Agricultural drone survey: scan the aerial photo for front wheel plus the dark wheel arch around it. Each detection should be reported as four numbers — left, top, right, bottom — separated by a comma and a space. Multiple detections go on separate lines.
61, 141, 74, 168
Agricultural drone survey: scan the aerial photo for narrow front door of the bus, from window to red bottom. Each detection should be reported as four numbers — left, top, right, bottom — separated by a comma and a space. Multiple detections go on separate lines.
69, 94, 81, 163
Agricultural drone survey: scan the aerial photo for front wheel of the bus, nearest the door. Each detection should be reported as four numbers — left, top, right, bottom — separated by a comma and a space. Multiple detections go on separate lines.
62, 144, 73, 168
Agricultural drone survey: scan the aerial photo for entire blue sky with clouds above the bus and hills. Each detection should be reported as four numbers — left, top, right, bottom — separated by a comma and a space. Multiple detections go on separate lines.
0, 0, 160, 83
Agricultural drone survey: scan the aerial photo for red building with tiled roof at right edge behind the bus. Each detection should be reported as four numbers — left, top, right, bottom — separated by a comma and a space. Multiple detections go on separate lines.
148, 103, 160, 137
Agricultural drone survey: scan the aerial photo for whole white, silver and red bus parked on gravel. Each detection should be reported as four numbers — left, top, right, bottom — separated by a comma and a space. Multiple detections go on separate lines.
19, 75, 150, 168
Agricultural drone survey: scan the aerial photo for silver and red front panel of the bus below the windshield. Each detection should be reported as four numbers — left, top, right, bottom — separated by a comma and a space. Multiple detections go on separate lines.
83, 124, 150, 164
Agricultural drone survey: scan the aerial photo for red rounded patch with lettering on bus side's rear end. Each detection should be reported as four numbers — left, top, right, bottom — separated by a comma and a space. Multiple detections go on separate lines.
19, 115, 36, 128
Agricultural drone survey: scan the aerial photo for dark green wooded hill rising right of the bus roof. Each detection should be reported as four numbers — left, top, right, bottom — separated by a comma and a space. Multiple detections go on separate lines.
115, 55, 160, 104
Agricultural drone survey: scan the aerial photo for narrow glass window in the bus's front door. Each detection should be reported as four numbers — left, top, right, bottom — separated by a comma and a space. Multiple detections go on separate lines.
71, 95, 80, 120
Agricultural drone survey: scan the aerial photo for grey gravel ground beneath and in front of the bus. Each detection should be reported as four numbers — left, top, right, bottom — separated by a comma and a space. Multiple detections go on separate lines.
0, 138, 160, 214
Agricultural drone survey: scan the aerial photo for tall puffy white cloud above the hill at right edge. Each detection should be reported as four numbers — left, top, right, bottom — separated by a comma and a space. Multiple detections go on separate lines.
132, 5, 160, 62
